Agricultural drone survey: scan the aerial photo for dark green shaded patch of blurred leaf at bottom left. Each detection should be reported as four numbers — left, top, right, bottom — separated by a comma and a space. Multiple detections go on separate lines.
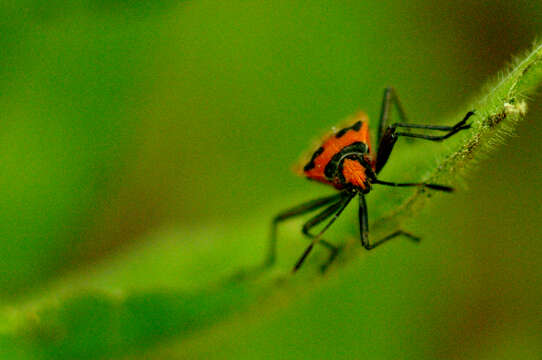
0, 283, 250, 359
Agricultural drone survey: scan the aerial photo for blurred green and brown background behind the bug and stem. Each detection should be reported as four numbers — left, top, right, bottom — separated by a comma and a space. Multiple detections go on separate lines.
0, 0, 542, 359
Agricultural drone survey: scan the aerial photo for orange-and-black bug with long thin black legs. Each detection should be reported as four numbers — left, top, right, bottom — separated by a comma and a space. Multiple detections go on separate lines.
264, 87, 474, 272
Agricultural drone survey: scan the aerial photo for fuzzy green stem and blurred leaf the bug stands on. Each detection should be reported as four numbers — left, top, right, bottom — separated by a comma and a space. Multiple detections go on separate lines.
0, 45, 542, 359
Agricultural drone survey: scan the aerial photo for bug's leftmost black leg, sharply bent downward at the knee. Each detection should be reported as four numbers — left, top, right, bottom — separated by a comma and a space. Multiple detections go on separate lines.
264, 193, 343, 267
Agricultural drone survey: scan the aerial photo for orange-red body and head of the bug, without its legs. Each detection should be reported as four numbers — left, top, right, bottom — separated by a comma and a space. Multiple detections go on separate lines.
303, 112, 372, 188
